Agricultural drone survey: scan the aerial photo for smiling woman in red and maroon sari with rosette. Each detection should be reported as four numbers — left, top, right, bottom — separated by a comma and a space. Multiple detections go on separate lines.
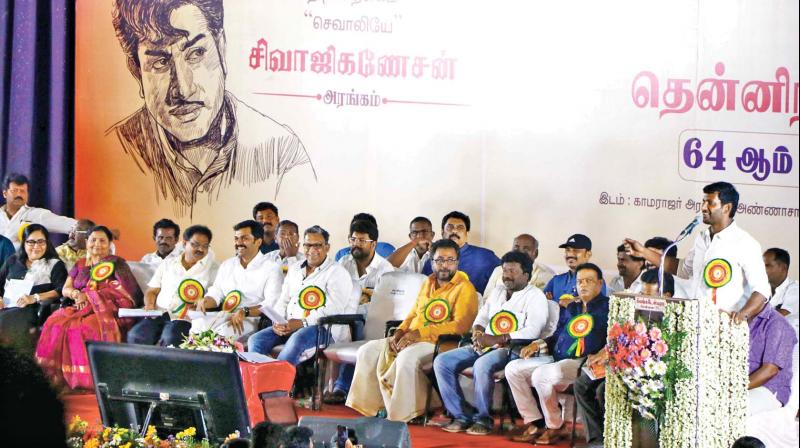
36, 226, 142, 389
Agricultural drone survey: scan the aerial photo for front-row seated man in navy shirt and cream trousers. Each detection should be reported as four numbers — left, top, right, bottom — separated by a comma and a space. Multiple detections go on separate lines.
506, 263, 608, 445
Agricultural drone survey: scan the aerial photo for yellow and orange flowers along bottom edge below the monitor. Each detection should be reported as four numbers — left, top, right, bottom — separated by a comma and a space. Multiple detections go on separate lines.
67, 415, 239, 448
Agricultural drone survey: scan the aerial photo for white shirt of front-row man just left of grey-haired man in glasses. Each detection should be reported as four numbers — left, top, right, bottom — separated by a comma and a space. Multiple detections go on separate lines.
206, 252, 283, 308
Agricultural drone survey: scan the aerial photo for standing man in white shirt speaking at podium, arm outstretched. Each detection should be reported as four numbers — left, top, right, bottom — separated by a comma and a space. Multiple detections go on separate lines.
625, 182, 771, 323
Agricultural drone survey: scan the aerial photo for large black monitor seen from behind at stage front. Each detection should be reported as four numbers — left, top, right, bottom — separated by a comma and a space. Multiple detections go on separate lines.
86, 341, 250, 442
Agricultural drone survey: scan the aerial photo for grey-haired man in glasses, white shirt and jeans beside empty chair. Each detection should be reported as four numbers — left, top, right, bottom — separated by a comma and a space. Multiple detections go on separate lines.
247, 226, 357, 365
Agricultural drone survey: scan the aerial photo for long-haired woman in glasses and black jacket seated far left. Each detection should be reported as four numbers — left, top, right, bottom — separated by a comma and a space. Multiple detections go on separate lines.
0, 224, 67, 356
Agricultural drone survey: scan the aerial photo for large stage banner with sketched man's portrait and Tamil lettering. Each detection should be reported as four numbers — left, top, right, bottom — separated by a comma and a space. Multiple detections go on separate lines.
75, 0, 800, 278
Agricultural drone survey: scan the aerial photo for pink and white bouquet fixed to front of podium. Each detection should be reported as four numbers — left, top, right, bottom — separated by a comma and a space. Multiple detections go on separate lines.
608, 320, 691, 420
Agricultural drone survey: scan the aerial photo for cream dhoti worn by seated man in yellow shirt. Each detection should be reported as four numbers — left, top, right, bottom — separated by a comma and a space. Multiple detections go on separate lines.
347, 338, 439, 422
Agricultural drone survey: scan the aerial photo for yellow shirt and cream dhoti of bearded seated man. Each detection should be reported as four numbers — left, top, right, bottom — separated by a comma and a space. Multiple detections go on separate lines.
347, 271, 478, 421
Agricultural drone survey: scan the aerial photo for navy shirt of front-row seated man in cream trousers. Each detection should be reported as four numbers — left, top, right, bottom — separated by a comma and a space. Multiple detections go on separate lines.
545, 293, 608, 361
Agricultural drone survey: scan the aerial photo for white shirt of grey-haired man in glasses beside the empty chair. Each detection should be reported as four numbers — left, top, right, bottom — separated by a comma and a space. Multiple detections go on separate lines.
276, 254, 358, 326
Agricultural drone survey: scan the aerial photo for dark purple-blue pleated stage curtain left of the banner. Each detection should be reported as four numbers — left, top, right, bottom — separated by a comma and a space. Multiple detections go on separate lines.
0, 0, 75, 216
